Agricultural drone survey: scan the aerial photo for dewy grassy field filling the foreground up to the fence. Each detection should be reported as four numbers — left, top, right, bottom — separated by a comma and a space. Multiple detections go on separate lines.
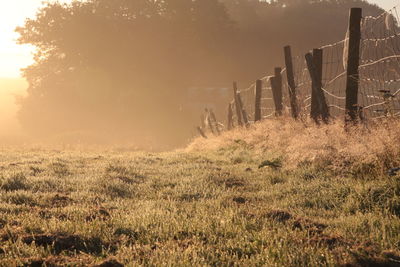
0, 122, 400, 266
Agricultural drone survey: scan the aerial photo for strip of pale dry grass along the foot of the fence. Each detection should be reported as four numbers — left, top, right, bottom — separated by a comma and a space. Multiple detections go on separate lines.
187, 118, 400, 174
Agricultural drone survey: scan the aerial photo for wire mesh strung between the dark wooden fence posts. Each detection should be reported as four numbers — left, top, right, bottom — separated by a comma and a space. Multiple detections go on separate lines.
199, 7, 400, 136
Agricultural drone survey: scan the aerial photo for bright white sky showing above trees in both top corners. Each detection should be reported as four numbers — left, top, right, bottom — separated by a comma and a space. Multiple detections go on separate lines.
0, 0, 400, 77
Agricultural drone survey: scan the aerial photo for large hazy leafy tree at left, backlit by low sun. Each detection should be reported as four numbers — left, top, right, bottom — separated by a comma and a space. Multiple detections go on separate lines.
17, 0, 231, 148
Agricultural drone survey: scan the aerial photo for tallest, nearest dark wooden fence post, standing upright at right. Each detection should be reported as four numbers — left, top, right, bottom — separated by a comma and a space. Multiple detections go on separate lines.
345, 8, 362, 125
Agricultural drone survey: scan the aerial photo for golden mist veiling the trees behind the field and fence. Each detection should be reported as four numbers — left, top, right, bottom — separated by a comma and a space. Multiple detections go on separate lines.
4, 0, 382, 150
